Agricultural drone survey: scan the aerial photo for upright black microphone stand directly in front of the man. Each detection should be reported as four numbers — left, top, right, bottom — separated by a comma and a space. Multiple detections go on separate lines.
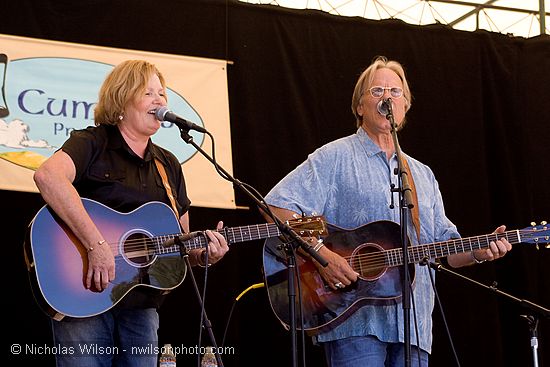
383, 98, 414, 367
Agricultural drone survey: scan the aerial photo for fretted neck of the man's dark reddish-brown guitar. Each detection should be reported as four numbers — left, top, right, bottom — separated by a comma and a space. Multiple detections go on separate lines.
385, 230, 522, 266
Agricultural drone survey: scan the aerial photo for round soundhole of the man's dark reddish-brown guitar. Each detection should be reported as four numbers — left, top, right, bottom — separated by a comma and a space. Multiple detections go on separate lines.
351, 243, 388, 281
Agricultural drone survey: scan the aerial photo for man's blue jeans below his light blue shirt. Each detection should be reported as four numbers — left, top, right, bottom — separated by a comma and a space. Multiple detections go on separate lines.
322, 336, 428, 367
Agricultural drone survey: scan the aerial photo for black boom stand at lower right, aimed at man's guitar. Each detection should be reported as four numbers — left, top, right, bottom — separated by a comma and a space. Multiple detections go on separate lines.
429, 262, 550, 367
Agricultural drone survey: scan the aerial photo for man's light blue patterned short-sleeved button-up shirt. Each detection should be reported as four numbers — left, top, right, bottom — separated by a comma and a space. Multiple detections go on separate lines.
266, 128, 459, 353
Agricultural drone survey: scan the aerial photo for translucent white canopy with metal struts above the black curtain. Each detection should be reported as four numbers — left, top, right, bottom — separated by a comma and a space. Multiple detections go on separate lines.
240, 0, 550, 38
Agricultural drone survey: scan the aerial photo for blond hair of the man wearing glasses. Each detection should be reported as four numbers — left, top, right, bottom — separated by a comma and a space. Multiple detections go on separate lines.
351, 56, 412, 127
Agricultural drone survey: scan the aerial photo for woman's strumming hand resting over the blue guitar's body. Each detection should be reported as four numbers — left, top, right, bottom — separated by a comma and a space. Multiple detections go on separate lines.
86, 240, 115, 291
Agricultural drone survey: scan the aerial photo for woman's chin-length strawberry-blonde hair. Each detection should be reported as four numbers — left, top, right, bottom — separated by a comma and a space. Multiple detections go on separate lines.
94, 60, 166, 125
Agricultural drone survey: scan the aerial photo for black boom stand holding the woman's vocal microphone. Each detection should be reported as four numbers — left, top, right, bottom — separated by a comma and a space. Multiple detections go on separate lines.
177, 125, 328, 366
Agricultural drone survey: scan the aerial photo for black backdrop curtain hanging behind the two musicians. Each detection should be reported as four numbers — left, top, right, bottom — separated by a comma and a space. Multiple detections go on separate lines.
0, 0, 550, 366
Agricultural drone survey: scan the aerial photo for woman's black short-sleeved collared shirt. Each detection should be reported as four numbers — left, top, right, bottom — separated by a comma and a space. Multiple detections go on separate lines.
61, 125, 191, 308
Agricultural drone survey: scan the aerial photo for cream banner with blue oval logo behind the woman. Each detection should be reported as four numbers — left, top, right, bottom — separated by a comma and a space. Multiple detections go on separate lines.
0, 34, 236, 208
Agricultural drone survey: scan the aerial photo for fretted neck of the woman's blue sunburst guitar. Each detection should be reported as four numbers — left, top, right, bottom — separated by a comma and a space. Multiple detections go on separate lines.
154, 223, 281, 254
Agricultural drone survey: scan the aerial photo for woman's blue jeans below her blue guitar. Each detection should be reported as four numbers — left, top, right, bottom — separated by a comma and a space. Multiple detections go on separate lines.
52, 308, 159, 367
